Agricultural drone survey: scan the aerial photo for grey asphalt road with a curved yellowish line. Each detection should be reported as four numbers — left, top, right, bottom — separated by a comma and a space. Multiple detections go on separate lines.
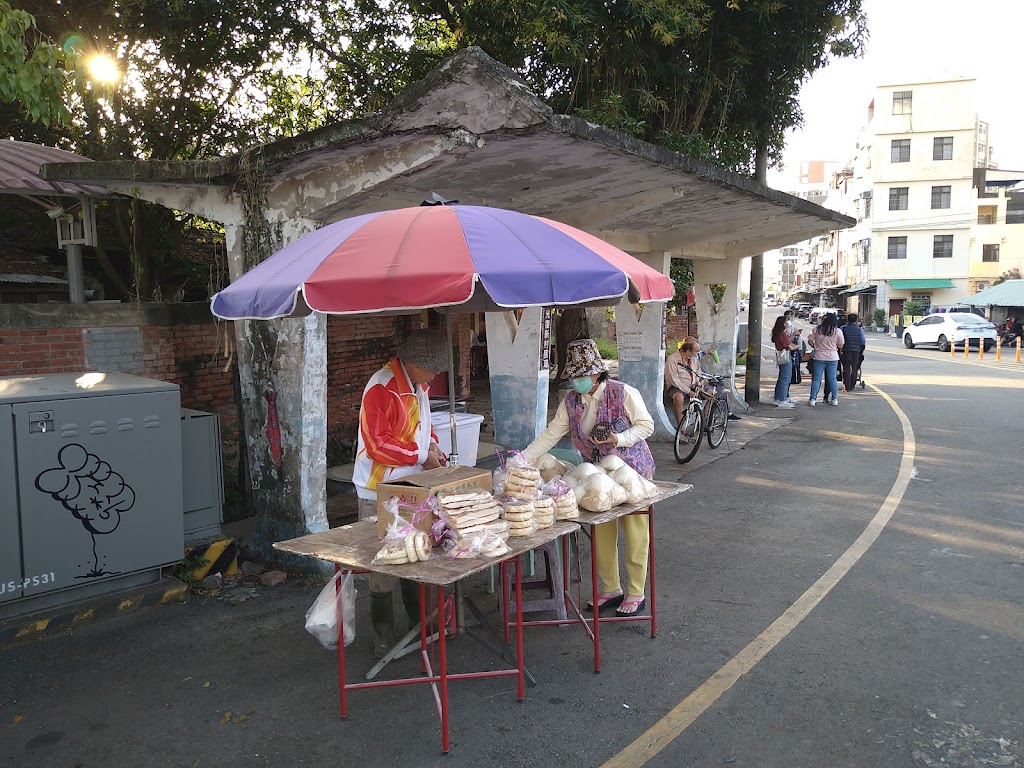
0, 309, 1024, 768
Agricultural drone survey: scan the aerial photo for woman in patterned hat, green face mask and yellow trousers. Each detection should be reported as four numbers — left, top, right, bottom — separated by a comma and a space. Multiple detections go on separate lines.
523, 339, 654, 616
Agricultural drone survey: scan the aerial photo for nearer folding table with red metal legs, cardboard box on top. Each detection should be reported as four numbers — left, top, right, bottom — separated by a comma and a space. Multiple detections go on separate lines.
273, 520, 580, 755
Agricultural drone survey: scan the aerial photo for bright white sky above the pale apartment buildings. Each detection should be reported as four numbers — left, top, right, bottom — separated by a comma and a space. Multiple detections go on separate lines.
768, 0, 1024, 188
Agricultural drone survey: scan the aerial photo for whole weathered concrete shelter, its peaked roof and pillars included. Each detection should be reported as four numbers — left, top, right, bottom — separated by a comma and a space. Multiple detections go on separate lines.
42, 48, 855, 550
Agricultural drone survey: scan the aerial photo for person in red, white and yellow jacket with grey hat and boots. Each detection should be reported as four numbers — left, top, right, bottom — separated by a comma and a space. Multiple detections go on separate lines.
352, 330, 449, 658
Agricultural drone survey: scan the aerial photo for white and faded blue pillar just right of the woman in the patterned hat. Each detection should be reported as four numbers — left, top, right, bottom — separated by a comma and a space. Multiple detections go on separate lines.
615, 300, 676, 439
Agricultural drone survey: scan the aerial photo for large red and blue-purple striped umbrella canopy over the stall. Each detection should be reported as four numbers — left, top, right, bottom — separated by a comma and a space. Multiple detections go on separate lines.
213, 205, 673, 319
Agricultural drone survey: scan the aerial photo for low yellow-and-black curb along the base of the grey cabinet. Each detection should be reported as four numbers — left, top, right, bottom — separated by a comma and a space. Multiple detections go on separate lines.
0, 577, 189, 648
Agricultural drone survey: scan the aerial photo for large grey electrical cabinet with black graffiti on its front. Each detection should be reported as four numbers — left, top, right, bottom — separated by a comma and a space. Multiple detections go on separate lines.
0, 373, 184, 603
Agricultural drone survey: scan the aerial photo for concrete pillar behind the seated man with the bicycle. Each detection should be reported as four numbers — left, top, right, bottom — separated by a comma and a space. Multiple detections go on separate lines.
693, 257, 760, 413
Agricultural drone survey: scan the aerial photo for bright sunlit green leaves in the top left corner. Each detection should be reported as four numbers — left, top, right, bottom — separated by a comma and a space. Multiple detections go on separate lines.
0, 0, 71, 127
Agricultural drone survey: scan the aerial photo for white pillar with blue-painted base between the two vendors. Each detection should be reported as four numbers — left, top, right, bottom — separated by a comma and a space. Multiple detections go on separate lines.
486, 307, 550, 450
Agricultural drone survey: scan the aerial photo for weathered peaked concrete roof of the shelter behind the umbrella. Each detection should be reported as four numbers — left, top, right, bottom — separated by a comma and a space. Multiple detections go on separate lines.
42, 48, 855, 258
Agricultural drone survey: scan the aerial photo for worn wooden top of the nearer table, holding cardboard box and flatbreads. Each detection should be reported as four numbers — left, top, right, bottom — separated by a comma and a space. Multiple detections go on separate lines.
273, 520, 580, 587
